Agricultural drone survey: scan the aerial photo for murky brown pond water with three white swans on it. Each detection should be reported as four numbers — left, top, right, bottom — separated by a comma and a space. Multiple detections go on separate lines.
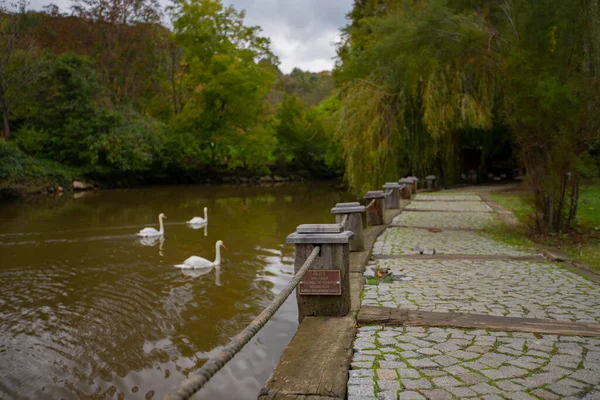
0, 183, 350, 399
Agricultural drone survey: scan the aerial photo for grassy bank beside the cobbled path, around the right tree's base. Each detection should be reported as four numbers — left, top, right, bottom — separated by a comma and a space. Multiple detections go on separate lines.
491, 179, 600, 269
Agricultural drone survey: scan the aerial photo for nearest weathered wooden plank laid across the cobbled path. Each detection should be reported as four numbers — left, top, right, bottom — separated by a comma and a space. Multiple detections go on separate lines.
357, 307, 600, 337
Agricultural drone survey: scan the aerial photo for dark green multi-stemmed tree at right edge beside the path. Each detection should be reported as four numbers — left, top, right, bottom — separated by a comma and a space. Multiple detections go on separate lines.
503, 0, 600, 232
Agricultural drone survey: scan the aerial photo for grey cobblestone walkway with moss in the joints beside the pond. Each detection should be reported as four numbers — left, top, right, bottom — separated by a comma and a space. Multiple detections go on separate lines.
348, 191, 600, 400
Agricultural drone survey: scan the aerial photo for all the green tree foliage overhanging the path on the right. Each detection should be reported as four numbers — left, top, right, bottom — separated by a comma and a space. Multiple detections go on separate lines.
336, 0, 600, 231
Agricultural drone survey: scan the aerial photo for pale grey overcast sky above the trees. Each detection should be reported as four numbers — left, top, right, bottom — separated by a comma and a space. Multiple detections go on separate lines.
24, 0, 353, 73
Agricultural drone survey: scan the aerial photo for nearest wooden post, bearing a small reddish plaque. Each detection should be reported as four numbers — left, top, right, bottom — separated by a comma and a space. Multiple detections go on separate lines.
286, 224, 354, 322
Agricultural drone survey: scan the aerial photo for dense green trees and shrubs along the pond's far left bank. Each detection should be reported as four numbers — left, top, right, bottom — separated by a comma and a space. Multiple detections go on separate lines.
0, 0, 341, 192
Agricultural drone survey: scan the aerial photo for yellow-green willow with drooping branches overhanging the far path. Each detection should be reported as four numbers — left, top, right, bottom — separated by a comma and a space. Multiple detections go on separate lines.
337, 0, 499, 189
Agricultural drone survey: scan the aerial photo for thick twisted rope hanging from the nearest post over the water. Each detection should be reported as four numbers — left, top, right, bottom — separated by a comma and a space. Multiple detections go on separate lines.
165, 246, 321, 400
